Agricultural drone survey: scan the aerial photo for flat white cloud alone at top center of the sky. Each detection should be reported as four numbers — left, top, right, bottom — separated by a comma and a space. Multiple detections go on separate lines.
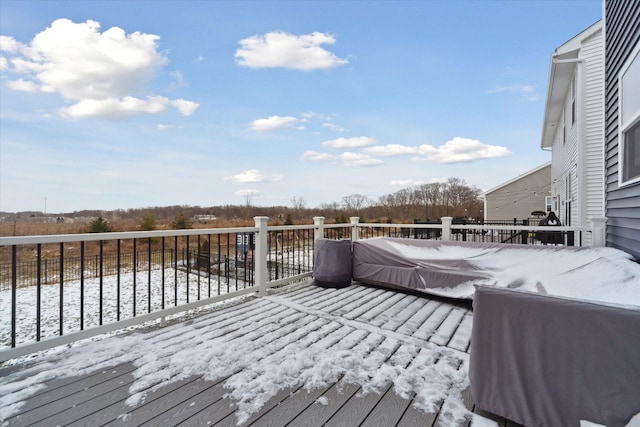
235, 31, 348, 71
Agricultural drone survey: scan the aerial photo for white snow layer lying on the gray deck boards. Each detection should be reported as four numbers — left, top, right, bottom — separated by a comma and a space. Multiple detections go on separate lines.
0, 283, 484, 425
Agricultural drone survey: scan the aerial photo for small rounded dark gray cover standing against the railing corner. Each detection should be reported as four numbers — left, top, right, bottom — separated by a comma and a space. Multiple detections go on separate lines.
313, 239, 353, 288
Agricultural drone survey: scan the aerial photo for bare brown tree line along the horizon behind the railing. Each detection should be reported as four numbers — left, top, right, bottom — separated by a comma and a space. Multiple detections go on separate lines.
80, 178, 483, 232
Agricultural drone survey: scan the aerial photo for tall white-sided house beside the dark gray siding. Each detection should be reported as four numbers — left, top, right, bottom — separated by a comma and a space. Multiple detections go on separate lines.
540, 21, 604, 234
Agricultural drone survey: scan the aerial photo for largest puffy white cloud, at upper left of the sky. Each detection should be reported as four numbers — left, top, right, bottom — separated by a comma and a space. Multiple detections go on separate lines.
0, 19, 198, 118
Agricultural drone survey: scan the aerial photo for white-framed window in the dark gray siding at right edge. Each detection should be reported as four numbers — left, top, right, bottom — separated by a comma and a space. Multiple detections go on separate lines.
618, 45, 640, 185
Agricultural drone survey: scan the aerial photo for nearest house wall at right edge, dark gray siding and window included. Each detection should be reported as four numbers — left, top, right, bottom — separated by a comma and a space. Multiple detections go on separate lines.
604, 0, 640, 260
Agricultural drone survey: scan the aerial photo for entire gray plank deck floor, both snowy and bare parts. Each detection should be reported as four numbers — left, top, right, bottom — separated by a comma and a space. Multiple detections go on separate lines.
0, 282, 512, 426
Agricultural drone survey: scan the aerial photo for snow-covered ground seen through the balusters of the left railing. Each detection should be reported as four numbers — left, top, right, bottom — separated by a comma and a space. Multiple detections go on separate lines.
0, 268, 244, 346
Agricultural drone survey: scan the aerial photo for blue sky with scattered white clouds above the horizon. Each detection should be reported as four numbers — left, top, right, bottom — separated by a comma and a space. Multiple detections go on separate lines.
0, 0, 602, 213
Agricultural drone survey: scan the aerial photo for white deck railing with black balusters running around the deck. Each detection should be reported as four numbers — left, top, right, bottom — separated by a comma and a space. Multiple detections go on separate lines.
0, 217, 604, 362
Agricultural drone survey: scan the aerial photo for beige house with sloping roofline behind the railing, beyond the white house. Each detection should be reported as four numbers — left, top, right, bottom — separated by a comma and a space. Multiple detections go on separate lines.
483, 162, 554, 221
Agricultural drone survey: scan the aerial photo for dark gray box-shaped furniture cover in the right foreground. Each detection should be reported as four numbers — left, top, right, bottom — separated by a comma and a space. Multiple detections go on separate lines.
469, 286, 640, 427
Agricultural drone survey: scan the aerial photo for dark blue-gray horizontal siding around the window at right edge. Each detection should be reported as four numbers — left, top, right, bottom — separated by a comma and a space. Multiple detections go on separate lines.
605, 0, 640, 260
